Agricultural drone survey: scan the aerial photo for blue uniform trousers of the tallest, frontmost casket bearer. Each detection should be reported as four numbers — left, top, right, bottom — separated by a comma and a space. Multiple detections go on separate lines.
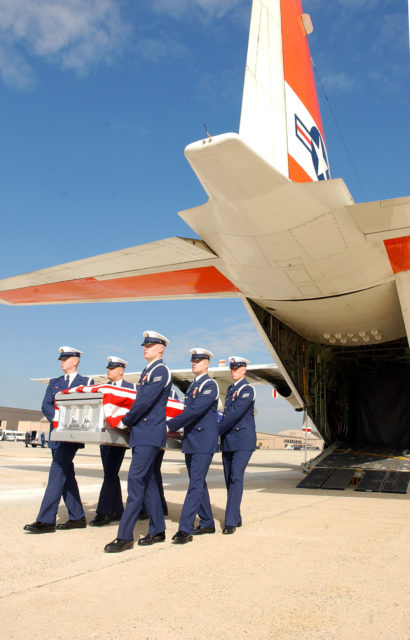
117, 445, 165, 540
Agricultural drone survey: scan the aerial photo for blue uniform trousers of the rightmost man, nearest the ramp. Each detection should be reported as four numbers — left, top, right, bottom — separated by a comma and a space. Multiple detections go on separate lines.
222, 449, 253, 527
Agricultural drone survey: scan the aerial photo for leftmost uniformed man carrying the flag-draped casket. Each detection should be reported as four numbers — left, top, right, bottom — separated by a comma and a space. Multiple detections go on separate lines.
24, 346, 94, 533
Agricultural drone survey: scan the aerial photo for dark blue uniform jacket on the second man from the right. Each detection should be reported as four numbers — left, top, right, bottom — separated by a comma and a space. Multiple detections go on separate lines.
167, 374, 219, 453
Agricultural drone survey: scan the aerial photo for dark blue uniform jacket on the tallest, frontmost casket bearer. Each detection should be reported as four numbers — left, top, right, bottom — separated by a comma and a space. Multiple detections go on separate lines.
122, 360, 172, 447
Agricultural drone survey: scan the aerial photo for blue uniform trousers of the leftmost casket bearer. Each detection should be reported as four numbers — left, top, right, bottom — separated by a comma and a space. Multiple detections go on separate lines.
37, 442, 84, 524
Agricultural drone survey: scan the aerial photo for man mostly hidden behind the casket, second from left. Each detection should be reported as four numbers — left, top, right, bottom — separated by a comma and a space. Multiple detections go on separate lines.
90, 356, 135, 527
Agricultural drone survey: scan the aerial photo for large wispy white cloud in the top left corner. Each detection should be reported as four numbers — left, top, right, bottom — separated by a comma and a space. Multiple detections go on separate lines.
0, 0, 129, 87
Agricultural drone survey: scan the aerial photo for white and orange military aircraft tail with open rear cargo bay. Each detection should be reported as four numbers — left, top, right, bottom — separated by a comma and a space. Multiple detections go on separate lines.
0, 0, 410, 446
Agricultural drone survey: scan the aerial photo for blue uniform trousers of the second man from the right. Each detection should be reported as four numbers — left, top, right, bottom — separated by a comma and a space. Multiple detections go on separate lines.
179, 453, 215, 534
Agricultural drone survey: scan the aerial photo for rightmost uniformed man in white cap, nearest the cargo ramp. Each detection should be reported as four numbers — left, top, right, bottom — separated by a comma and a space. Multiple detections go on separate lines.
219, 356, 256, 534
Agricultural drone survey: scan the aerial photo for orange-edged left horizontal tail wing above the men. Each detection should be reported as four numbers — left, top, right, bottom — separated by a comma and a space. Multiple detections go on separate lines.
0, 237, 239, 305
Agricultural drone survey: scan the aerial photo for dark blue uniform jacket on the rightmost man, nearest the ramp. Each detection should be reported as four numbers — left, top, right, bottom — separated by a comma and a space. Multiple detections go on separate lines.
219, 378, 256, 451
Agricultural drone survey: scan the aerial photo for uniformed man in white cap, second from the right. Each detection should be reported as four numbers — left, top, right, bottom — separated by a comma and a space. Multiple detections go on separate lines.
167, 347, 219, 544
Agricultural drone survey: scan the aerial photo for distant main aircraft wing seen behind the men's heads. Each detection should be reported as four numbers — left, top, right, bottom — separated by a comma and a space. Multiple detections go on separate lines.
31, 364, 300, 409
